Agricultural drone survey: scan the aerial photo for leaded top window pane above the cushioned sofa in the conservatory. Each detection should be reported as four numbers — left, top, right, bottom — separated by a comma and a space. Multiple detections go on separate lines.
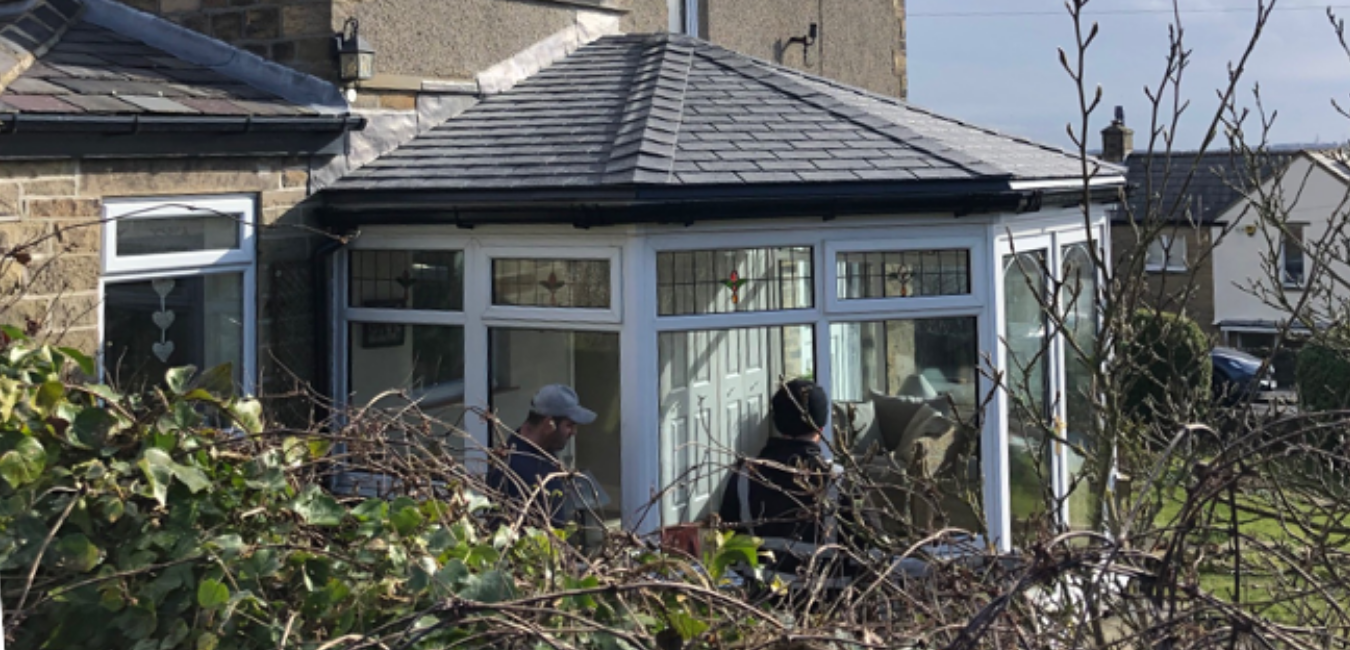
836, 249, 971, 300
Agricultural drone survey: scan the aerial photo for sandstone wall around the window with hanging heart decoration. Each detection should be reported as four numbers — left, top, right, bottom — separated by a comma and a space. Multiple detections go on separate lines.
0, 158, 323, 410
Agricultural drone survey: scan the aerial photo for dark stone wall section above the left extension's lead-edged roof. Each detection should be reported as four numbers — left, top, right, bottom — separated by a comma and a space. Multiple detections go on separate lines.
122, 0, 336, 80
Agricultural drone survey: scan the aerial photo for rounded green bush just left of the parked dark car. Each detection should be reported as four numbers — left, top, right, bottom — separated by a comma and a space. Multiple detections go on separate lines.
1122, 309, 1214, 423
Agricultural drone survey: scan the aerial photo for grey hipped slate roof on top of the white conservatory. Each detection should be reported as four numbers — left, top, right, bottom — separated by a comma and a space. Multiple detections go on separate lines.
331, 34, 1123, 192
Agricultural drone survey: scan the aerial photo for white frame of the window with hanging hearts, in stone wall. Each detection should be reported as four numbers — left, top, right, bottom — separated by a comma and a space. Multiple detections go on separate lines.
97, 195, 258, 395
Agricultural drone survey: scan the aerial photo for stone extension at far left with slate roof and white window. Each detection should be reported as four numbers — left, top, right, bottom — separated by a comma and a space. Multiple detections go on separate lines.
0, 0, 362, 418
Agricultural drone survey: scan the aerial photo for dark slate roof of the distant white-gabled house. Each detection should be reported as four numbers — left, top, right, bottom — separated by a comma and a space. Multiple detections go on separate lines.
1115, 150, 1299, 224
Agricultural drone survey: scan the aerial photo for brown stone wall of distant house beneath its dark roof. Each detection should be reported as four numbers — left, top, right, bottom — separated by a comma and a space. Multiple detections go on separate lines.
1111, 226, 1219, 338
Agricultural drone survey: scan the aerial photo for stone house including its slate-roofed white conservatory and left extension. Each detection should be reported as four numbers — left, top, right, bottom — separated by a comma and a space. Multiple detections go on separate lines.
0, 0, 1125, 547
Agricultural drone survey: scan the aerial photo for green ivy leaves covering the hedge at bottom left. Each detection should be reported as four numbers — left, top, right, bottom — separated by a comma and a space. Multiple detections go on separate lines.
0, 336, 757, 650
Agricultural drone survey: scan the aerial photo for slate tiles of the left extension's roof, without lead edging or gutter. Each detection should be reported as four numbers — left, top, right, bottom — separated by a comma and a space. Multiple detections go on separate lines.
0, 0, 342, 118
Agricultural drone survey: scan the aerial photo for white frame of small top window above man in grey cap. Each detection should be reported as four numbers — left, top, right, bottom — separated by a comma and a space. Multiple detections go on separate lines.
477, 242, 624, 324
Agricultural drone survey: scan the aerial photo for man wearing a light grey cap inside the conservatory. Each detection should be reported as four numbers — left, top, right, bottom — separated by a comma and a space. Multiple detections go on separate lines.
487, 384, 595, 528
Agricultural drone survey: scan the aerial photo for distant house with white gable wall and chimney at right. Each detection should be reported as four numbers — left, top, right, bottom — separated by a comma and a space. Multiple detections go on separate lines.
1103, 113, 1350, 386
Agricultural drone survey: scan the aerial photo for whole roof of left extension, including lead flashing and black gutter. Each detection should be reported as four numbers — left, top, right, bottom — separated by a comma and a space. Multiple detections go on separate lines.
0, 0, 350, 154
